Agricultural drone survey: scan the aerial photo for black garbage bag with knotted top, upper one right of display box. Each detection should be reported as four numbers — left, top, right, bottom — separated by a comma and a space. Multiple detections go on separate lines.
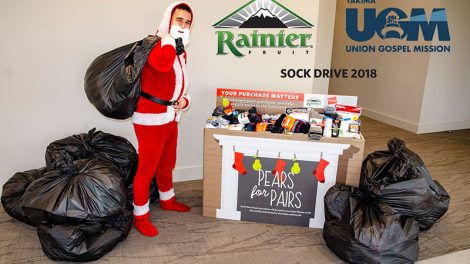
359, 138, 450, 231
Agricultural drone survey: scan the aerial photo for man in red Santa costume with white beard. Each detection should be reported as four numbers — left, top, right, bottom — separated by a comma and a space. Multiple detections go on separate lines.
132, 2, 193, 236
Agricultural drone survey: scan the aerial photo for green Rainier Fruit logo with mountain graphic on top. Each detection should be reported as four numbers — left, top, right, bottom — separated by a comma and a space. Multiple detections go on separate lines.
213, 0, 313, 58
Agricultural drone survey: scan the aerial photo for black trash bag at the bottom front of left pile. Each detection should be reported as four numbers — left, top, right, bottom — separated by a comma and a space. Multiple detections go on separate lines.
37, 211, 132, 262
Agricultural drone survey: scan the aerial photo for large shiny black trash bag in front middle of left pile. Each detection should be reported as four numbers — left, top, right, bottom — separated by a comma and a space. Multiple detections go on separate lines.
22, 158, 126, 225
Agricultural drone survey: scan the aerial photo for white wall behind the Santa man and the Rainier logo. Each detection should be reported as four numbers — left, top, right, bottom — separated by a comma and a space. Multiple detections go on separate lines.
0, 0, 327, 189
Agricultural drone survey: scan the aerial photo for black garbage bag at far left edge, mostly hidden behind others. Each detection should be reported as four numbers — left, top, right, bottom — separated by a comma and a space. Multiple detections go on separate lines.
1, 168, 46, 226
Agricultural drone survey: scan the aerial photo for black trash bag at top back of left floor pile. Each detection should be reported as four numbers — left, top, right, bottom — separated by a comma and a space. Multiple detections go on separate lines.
46, 129, 138, 186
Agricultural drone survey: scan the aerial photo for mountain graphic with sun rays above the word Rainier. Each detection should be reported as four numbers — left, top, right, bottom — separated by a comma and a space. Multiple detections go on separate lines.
213, 0, 313, 28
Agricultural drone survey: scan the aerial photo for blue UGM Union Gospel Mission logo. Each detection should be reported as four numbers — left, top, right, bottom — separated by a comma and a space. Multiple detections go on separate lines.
346, 0, 451, 53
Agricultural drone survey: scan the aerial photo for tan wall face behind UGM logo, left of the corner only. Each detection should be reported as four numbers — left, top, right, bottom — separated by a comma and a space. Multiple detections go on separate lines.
329, 0, 439, 132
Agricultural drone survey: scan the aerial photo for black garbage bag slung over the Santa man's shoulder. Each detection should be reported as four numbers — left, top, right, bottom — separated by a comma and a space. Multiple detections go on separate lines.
85, 36, 162, 119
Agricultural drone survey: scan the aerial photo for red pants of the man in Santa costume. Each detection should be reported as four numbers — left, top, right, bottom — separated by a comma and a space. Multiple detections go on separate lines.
134, 122, 178, 209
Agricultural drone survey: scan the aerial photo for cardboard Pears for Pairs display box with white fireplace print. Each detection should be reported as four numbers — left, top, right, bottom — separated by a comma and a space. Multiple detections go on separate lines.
203, 89, 365, 228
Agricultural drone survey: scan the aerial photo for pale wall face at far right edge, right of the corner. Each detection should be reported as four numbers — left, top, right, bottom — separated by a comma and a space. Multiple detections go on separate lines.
418, 0, 470, 133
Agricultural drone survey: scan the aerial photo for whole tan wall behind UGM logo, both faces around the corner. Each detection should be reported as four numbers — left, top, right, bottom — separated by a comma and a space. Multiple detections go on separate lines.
330, 0, 470, 133
